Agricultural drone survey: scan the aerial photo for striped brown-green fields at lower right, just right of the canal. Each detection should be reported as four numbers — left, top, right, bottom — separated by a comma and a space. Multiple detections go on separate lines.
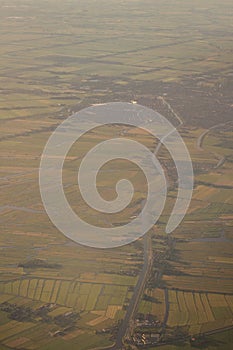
139, 289, 233, 335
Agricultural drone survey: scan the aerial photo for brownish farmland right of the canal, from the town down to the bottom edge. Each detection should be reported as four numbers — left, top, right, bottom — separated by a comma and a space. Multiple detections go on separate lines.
134, 126, 233, 349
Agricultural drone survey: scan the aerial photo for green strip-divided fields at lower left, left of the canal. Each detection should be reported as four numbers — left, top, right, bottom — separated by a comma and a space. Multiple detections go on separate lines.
0, 278, 131, 349
